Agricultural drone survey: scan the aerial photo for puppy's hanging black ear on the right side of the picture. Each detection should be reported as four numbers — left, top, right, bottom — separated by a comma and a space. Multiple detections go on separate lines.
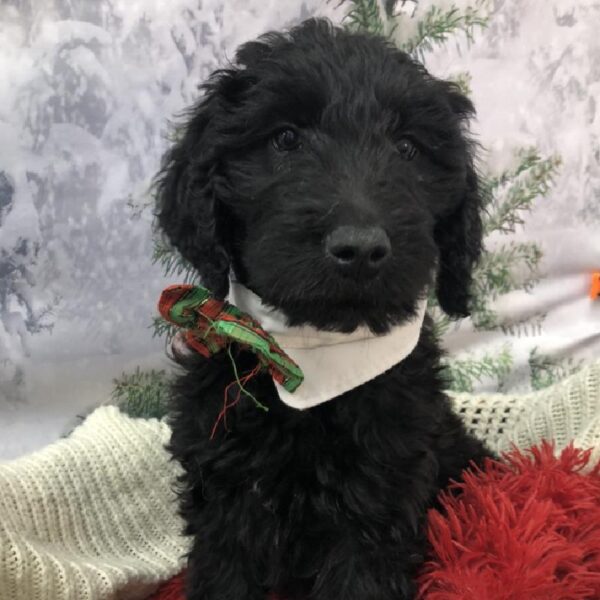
435, 84, 483, 318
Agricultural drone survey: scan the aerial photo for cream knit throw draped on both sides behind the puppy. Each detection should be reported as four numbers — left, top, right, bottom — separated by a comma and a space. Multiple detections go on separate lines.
0, 362, 600, 600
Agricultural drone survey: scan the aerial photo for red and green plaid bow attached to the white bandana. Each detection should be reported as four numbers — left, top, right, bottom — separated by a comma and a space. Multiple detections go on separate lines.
158, 284, 304, 392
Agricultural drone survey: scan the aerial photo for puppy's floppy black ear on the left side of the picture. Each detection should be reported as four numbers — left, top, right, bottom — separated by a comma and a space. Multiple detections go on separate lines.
155, 86, 229, 298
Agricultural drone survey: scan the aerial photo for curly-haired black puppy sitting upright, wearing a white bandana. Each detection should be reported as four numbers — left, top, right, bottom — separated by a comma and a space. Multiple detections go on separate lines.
158, 20, 487, 600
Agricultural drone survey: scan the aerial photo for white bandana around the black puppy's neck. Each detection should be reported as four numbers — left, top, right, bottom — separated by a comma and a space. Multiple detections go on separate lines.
229, 283, 427, 410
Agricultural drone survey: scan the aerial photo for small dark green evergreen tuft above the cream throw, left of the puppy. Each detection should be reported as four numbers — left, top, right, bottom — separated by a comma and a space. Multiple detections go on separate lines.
112, 367, 168, 419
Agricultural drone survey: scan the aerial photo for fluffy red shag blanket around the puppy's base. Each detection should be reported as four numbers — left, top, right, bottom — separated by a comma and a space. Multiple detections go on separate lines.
152, 443, 600, 600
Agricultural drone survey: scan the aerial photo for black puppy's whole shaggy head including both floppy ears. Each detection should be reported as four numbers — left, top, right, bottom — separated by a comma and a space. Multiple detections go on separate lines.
159, 20, 481, 332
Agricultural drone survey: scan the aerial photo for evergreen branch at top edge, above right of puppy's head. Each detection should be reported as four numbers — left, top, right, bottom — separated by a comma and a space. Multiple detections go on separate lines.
401, 0, 489, 60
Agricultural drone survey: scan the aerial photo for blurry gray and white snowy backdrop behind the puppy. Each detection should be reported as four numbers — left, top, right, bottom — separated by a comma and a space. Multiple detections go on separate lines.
0, 0, 600, 459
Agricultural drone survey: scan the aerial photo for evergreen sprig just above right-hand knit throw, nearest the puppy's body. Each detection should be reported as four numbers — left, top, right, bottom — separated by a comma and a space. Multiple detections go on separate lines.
444, 347, 513, 393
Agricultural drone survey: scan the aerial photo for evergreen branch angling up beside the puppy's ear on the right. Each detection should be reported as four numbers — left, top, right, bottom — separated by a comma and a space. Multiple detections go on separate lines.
484, 149, 561, 234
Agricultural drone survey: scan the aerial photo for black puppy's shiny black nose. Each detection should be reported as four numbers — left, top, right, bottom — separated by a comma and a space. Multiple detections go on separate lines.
325, 225, 392, 274
